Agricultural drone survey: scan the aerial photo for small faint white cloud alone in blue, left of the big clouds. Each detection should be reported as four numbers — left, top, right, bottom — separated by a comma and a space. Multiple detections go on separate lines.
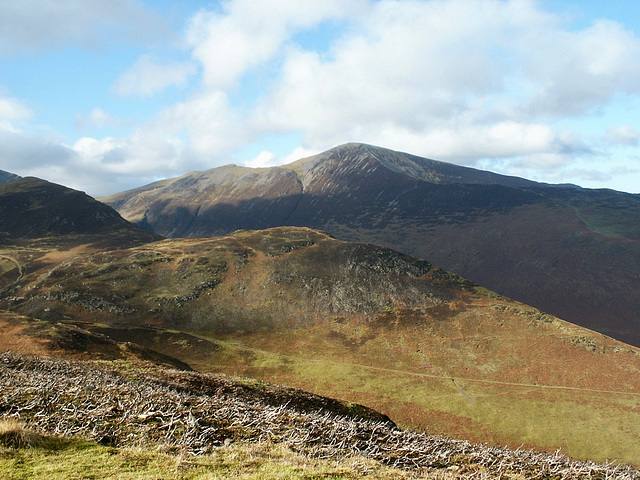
111, 55, 197, 96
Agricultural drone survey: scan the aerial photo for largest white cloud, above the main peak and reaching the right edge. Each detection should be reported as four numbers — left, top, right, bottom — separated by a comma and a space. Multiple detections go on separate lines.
252, 0, 640, 167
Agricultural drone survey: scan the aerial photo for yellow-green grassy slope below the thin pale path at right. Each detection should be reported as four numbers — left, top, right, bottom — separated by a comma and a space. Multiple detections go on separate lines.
204, 338, 640, 464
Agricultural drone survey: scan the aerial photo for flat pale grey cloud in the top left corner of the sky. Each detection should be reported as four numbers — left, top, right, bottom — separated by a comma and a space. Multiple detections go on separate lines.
0, 0, 171, 55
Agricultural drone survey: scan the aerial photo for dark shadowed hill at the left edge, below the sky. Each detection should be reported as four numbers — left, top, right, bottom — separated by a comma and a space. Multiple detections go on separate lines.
0, 177, 161, 245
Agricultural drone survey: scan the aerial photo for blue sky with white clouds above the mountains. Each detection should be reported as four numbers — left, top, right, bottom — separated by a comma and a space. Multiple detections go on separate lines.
0, 0, 640, 196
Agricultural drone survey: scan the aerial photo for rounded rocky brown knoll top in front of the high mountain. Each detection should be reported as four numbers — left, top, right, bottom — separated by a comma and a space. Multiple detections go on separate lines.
5, 227, 472, 331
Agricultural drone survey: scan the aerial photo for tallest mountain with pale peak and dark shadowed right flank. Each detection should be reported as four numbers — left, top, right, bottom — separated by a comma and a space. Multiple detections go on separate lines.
101, 144, 640, 346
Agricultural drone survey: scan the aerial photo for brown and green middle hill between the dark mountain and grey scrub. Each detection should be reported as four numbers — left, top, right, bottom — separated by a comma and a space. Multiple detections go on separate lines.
0, 228, 640, 464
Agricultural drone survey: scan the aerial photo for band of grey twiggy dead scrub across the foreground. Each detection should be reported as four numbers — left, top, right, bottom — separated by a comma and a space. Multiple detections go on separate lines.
0, 352, 640, 480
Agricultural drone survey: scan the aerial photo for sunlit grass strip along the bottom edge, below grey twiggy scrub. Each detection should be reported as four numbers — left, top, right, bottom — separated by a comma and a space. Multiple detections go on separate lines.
0, 438, 432, 480
